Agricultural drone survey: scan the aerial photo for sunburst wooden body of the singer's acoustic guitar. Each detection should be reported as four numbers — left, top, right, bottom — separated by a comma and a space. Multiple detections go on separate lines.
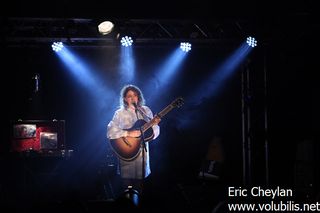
110, 119, 154, 161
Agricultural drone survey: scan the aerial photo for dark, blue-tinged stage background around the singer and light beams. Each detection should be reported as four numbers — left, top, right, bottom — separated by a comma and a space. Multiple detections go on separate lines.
0, 1, 320, 212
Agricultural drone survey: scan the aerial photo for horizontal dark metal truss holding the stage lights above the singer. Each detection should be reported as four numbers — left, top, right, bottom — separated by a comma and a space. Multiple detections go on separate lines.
3, 17, 251, 46
